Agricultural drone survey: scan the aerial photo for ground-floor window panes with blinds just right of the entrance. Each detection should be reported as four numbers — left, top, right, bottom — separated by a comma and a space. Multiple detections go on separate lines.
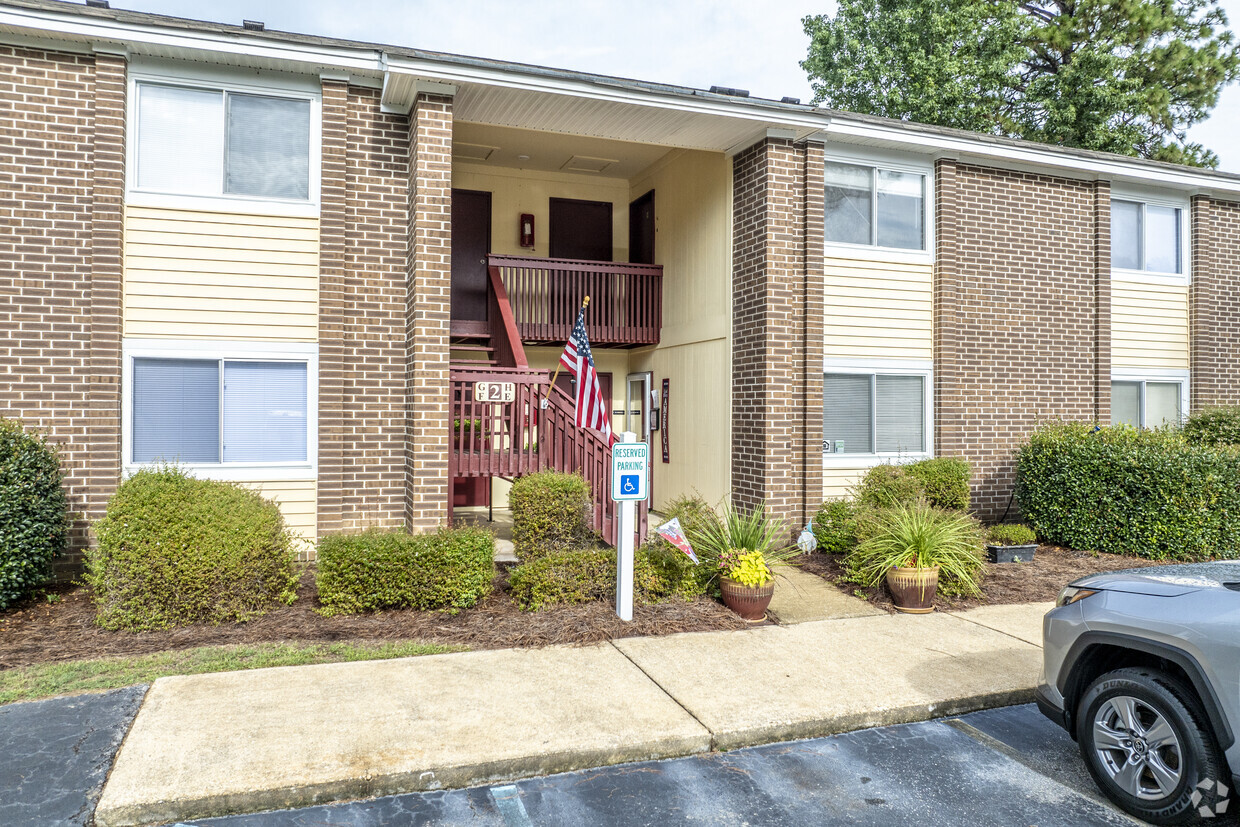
822, 373, 926, 454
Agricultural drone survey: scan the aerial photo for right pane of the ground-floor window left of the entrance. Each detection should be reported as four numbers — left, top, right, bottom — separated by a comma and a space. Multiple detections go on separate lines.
223, 362, 306, 462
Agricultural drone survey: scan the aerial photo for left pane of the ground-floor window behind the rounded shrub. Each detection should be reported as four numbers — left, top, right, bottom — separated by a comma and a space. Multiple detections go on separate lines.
133, 358, 219, 462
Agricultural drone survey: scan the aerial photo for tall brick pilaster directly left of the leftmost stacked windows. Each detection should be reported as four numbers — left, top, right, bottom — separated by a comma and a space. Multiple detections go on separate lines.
83, 55, 126, 555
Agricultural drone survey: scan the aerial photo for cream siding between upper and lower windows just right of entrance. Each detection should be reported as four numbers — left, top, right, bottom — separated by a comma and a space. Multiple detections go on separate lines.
823, 257, 934, 360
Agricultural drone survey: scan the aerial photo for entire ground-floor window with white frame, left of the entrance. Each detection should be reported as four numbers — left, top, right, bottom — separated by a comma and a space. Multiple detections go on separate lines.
125, 342, 317, 472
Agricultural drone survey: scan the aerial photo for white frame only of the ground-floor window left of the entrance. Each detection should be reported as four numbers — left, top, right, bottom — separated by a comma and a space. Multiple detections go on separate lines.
120, 338, 319, 482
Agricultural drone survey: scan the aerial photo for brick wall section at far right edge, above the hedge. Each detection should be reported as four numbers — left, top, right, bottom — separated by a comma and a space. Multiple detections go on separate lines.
1189, 196, 1240, 410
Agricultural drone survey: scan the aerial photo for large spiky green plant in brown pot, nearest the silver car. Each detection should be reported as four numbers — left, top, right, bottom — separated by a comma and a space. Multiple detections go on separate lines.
848, 502, 983, 614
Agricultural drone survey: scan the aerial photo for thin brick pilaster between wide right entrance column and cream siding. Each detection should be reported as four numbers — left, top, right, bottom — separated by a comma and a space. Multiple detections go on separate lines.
800, 143, 827, 526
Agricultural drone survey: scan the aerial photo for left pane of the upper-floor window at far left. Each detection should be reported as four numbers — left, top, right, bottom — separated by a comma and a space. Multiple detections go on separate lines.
138, 83, 224, 195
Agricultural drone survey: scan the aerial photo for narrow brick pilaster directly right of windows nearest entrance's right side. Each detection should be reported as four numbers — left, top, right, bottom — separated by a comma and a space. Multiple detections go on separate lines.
932, 159, 963, 456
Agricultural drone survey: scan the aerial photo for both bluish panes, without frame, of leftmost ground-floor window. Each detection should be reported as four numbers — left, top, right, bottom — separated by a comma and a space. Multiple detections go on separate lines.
133, 358, 309, 464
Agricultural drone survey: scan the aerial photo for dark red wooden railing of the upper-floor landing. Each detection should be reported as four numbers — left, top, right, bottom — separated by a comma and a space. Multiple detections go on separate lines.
487, 255, 663, 346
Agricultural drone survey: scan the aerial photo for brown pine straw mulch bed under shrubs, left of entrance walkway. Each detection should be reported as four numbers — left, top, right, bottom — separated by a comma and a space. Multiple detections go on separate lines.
0, 569, 749, 670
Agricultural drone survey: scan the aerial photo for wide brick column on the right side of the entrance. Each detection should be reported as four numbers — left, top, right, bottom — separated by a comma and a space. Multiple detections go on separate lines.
732, 138, 822, 528
